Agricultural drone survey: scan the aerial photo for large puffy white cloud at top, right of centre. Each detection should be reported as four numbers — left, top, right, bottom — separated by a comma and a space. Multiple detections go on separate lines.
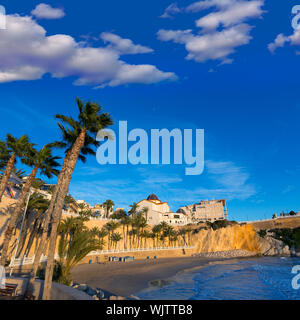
158, 0, 264, 64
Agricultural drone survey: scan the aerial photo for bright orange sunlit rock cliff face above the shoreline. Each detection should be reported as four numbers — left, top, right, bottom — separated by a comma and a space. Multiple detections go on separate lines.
192, 225, 261, 253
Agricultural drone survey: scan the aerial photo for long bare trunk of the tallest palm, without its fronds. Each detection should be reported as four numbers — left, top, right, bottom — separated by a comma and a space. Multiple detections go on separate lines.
43, 130, 86, 300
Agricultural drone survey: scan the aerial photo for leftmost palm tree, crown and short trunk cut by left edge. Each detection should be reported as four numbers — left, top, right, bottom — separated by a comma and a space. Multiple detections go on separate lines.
0, 134, 33, 202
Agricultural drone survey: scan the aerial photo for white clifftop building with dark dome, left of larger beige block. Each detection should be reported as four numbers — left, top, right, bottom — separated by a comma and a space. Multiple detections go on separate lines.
137, 194, 188, 226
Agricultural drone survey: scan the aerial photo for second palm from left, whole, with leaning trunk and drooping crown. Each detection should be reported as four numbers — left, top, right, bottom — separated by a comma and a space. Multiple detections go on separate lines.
1, 145, 59, 265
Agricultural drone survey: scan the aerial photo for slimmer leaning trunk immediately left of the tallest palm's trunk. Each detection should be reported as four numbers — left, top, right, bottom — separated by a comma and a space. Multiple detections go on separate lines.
26, 151, 71, 294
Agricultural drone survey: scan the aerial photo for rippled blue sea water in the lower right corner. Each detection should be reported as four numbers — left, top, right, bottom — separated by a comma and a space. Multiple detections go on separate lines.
137, 257, 300, 300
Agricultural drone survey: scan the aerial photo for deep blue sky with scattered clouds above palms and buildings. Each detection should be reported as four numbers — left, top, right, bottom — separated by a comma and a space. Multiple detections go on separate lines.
0, 0, 300, 220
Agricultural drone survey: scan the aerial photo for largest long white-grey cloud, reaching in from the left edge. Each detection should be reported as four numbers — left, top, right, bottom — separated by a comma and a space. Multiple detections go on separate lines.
0, 15, 176, 87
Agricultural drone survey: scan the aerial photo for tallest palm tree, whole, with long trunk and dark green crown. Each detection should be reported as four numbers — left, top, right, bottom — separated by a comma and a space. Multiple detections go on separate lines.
43, 98, 113, 300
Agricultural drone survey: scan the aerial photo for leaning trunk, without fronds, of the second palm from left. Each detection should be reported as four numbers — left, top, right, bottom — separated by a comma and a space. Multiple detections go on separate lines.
0, 167, 39, 266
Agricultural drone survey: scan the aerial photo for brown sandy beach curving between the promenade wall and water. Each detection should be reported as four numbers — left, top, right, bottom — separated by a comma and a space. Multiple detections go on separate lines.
72, 257, 219, 297
